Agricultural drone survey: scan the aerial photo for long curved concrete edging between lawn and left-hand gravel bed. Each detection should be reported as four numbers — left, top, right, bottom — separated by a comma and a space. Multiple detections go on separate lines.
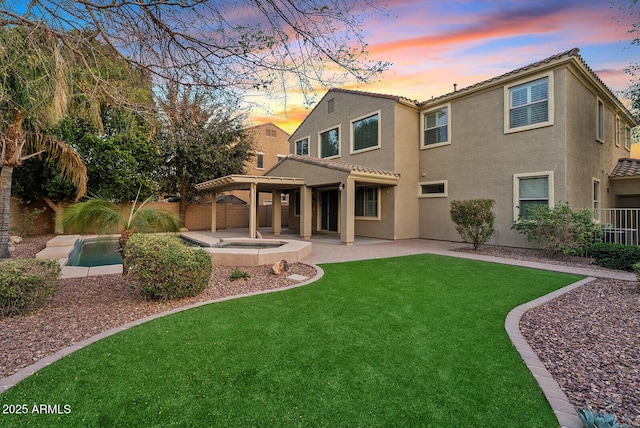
0, 263, 324, 394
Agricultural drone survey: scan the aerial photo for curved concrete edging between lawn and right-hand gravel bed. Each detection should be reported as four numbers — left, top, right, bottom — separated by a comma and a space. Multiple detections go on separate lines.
504, 277, 595, 428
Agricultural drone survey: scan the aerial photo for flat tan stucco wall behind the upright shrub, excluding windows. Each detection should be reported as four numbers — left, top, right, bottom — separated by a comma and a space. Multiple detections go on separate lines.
416, 69, 566, 246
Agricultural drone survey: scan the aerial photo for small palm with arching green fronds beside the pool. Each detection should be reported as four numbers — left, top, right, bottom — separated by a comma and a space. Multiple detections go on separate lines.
62, 193, 180, 252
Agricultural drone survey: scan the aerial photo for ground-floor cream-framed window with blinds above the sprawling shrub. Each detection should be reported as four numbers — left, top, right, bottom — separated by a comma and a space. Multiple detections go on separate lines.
513, 171, 554, 221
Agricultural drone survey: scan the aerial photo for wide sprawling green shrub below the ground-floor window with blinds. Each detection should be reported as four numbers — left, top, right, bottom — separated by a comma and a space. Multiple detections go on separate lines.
511, 203, 602, 256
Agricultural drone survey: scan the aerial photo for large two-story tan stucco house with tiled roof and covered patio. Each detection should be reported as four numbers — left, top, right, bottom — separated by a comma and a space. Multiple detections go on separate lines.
258, 49, 640, 246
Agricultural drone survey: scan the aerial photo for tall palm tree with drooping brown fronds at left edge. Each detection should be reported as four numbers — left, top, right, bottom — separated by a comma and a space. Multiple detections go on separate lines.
0, 28, 87, 258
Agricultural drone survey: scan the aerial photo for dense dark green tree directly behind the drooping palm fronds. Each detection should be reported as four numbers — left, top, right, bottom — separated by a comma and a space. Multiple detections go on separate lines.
13, 106, 163, 233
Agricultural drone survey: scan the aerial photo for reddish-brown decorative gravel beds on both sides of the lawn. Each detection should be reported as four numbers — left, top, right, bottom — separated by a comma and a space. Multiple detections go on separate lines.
0, 236, 640, 426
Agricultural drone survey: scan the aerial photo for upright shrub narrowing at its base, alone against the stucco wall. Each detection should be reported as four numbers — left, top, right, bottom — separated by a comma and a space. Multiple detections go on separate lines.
449, 199, 496, 250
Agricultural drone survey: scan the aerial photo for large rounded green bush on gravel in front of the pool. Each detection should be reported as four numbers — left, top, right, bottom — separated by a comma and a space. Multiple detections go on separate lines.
123, 233, 212, 300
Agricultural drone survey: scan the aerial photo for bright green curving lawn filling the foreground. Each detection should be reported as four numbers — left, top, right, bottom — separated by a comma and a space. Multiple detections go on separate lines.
0, 255, 579, 428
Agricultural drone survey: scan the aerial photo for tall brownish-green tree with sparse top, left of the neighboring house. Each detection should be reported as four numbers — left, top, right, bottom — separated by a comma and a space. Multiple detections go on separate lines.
160, 85, 253, 218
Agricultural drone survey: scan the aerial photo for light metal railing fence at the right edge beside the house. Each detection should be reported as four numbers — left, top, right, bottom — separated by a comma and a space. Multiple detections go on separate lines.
594, 208, 640, 245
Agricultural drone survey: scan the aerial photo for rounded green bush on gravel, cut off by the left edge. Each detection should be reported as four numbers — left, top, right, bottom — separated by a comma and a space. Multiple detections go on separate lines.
0, 258, 61, 317
